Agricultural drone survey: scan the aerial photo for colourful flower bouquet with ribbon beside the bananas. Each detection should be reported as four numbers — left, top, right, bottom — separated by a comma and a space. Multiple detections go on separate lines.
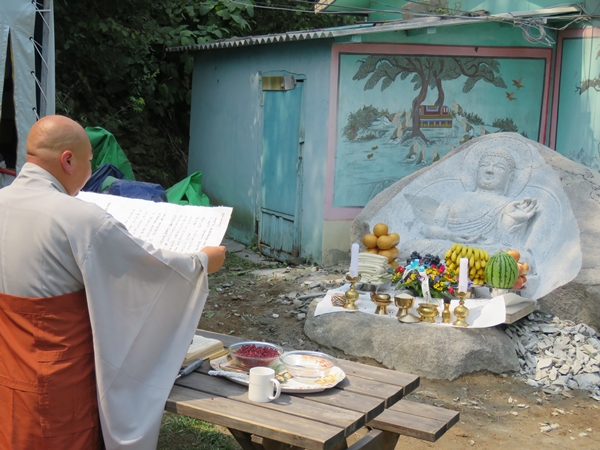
391, 252, 457, 301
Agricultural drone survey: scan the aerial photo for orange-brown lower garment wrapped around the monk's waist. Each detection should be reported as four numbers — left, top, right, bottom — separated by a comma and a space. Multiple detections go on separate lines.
0, 290, 103, 450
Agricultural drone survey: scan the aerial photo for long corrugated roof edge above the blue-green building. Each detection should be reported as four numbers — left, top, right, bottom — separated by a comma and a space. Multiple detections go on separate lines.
167, 6, 583, 52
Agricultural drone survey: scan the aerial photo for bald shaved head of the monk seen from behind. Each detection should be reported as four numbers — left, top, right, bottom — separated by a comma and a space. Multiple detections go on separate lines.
25, 116, 92, 195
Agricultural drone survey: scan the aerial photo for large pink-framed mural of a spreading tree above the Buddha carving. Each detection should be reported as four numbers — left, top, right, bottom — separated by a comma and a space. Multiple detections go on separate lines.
333, 45, 550, 208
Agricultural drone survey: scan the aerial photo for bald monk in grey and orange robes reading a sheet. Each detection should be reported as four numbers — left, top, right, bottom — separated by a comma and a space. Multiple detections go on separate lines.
0, 116, 225, 450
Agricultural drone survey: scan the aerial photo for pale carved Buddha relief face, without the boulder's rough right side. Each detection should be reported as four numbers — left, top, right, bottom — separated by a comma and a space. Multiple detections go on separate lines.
351, 133, 581, 298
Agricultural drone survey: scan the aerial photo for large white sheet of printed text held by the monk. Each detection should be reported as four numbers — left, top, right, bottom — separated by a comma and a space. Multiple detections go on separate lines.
77, 192, 232, 253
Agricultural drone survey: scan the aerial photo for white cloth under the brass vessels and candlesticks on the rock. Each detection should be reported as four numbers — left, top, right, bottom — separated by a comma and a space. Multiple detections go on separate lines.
315, 284, 518, 328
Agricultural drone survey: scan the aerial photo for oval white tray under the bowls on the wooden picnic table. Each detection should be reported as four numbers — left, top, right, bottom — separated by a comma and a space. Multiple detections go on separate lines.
210, 355, 346, 394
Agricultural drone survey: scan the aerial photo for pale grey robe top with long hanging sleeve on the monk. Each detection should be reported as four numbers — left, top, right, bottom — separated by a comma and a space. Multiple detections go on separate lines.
0, 163, 208, 450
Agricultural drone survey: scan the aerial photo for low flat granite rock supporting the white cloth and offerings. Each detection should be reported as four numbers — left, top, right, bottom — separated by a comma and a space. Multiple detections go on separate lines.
304, 300, 519, 380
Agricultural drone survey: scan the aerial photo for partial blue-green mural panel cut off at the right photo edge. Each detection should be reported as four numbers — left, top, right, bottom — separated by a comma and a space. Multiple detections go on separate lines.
550, 28, 600, 172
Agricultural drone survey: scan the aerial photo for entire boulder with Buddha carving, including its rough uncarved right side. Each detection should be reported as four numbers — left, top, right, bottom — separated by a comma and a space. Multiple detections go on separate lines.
351, 133, 600, 330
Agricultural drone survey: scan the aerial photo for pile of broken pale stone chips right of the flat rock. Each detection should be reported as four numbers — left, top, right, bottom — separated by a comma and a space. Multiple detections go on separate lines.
505, 312, 600, 400
